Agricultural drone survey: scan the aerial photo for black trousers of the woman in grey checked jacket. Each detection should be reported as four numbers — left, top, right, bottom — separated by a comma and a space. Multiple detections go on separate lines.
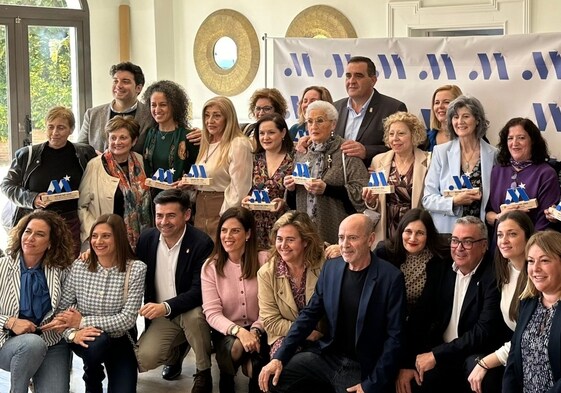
70, 333, 138, 393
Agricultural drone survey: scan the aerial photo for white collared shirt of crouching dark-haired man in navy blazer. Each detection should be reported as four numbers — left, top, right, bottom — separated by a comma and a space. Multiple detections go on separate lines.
155, 225, 187, 303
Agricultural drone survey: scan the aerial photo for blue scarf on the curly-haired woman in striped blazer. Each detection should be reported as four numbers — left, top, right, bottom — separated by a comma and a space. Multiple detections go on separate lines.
19, 256, 51, 325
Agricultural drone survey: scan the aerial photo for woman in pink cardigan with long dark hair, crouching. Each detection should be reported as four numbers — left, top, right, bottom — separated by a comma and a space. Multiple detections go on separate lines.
201, 207, 269, 393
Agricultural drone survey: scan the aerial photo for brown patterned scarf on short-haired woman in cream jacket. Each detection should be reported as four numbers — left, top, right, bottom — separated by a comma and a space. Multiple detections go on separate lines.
102, 150, 152, 250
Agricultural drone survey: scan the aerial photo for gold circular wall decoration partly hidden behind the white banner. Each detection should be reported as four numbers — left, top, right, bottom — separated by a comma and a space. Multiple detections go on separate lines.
286, 5, 357, 38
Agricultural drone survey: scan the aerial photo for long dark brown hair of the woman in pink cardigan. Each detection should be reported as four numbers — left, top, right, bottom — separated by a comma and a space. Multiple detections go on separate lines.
209, 207, 260, 279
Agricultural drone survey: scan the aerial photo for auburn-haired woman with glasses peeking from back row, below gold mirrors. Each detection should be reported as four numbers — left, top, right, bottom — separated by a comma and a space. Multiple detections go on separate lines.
240, 88, 288, 138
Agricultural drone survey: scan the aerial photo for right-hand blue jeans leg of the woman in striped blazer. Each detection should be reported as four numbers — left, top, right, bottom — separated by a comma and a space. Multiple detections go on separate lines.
33, 340, 72, 393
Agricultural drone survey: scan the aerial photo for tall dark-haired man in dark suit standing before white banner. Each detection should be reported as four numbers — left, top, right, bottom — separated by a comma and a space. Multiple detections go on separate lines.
334, 56, 407, 167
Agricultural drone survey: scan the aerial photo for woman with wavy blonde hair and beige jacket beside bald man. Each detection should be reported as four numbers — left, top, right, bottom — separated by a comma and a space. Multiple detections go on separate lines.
257, 211, 325, 356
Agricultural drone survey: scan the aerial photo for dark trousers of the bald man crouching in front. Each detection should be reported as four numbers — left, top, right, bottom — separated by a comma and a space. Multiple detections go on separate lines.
269, 349, 361, 393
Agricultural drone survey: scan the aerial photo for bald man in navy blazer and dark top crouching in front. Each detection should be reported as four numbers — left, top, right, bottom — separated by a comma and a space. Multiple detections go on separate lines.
259, 214, 405, 393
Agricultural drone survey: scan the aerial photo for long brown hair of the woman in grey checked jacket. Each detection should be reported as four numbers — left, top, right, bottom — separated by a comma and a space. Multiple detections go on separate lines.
87, 214, 135, 272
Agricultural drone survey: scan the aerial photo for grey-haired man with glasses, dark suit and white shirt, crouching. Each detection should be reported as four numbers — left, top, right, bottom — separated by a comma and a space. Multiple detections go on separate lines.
397, 216, 508, 393
